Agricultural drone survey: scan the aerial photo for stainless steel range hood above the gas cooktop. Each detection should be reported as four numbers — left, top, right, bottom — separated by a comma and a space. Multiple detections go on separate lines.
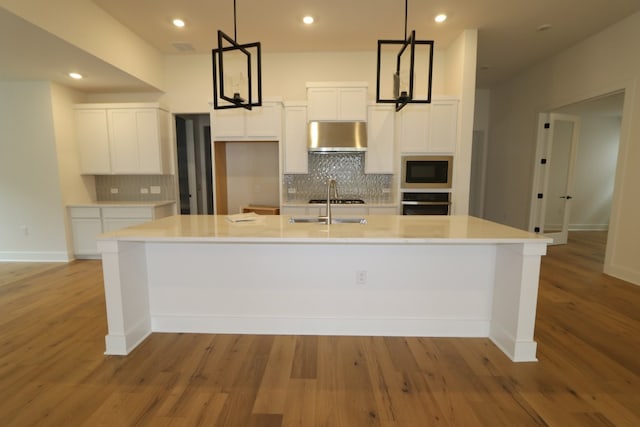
307, 122, 367, 152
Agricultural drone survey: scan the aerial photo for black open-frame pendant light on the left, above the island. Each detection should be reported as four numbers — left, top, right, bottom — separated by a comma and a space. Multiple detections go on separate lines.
211, 0, 262, 110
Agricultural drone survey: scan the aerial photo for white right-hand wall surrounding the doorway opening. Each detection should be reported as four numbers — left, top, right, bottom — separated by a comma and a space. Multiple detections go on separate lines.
485, 13, 640, 284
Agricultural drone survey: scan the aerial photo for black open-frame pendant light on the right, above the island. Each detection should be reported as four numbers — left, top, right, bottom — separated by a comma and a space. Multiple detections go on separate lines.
376, 0, 433, 111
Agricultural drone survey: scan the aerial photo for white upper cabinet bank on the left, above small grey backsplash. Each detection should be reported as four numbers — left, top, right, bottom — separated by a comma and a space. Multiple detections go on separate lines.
76, 104, 173, 175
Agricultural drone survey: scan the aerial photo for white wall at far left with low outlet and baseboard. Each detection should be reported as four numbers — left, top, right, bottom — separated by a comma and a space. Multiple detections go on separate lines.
0, 82, 68, 261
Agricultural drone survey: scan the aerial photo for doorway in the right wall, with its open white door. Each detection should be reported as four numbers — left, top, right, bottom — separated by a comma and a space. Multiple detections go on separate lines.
530, 92, 624, 244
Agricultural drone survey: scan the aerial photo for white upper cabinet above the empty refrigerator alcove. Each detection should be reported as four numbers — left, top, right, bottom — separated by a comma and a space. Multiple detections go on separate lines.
211, 102, 282, 141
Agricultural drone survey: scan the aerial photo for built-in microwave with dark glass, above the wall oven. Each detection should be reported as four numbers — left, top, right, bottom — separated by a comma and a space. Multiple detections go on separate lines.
400, 156, 453, 189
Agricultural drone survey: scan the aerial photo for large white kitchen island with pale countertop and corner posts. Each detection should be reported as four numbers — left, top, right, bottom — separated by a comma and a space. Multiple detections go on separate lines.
98, 215, 550, 361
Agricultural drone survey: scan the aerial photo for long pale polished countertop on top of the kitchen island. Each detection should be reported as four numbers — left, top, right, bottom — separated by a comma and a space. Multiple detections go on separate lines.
98, 215, 552, 244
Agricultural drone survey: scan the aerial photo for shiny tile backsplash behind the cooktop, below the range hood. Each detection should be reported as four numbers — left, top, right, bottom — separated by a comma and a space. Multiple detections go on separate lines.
283, 153, 393, 203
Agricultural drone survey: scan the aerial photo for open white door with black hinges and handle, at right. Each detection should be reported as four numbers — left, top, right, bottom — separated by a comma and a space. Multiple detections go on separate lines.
534, 113, 580, 245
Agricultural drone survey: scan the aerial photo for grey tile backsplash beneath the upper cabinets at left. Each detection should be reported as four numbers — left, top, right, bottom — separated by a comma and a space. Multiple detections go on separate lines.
96, 175, 176, 202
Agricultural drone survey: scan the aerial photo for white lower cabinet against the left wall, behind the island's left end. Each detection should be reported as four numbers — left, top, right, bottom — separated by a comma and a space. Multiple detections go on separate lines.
69, 203, 175, 258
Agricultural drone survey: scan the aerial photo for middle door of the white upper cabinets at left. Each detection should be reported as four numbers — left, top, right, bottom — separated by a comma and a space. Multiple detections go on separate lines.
108, 109, 139, 174
